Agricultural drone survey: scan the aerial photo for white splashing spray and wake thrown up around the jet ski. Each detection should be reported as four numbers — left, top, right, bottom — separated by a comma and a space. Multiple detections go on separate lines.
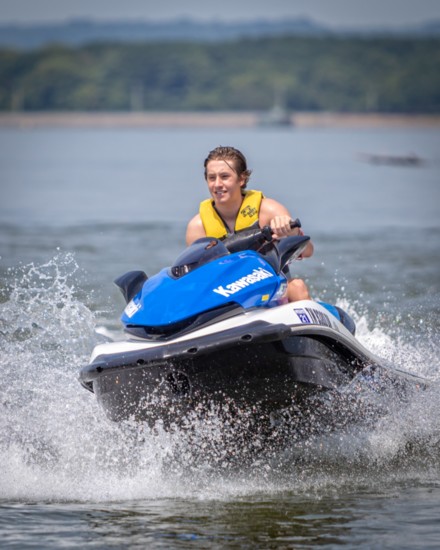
0, 254, 440, 501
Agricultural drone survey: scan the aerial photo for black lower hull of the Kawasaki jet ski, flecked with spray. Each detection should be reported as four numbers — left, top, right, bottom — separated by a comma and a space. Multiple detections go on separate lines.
81, 322, 372, 422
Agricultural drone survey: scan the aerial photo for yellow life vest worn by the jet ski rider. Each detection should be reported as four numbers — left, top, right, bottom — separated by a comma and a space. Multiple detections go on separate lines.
199, 190, 264, 239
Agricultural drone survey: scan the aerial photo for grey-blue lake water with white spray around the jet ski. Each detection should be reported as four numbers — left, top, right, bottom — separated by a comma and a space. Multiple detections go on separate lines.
0, 123, 440, 549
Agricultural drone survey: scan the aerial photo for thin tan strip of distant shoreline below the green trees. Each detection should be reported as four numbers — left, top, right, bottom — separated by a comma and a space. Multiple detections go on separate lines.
0, 112, 440, 128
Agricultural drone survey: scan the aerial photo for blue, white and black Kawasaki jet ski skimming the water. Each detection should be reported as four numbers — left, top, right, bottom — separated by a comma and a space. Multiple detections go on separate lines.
80, 220, 423, 432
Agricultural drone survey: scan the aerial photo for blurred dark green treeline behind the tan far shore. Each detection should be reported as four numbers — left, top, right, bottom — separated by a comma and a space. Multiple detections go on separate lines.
0, 37, 440, 113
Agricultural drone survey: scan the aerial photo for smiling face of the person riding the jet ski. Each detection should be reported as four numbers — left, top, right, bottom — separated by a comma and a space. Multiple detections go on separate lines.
206, 160, 245, 204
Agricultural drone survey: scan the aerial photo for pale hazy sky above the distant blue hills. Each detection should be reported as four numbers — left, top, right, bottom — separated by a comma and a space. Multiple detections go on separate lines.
0, 0, 440, 28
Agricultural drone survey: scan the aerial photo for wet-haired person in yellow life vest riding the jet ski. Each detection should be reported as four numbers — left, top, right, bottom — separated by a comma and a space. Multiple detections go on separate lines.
186, 147, 313, 302
